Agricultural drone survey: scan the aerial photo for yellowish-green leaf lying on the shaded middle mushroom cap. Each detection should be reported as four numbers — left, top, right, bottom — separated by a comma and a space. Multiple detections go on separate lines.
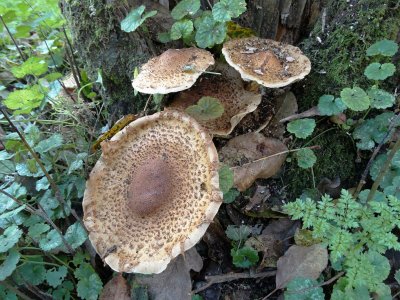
186, 96, 224, 121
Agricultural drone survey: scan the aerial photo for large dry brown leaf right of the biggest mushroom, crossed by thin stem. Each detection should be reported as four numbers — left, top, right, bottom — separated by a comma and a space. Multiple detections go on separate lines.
219, 132, 287, 191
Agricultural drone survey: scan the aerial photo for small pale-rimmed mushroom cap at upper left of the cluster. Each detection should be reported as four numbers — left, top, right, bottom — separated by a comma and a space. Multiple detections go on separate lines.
132, 48, 214, 94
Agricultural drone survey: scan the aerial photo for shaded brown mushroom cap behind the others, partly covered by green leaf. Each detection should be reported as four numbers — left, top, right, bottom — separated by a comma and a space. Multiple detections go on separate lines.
169, 64, 261, 136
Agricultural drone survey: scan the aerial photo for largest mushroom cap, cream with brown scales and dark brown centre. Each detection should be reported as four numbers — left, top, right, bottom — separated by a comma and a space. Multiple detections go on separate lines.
83, 111, 222, 274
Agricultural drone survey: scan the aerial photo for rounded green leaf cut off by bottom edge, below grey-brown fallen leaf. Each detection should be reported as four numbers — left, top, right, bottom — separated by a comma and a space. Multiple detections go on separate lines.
284, 277, 325, 300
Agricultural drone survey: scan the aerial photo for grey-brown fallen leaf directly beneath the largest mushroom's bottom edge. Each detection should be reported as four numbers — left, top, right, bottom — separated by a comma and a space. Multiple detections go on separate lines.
137, 248, 203, 300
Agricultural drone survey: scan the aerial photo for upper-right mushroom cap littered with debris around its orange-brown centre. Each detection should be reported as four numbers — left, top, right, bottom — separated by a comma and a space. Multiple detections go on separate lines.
222, 37, 311, 88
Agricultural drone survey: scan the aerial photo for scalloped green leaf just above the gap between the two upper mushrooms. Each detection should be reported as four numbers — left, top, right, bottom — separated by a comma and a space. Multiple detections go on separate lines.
195, 15, 227, 48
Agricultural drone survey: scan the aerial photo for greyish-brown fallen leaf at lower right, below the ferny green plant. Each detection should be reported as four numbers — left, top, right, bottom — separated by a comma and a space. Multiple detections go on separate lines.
276, 244, 328, 289
